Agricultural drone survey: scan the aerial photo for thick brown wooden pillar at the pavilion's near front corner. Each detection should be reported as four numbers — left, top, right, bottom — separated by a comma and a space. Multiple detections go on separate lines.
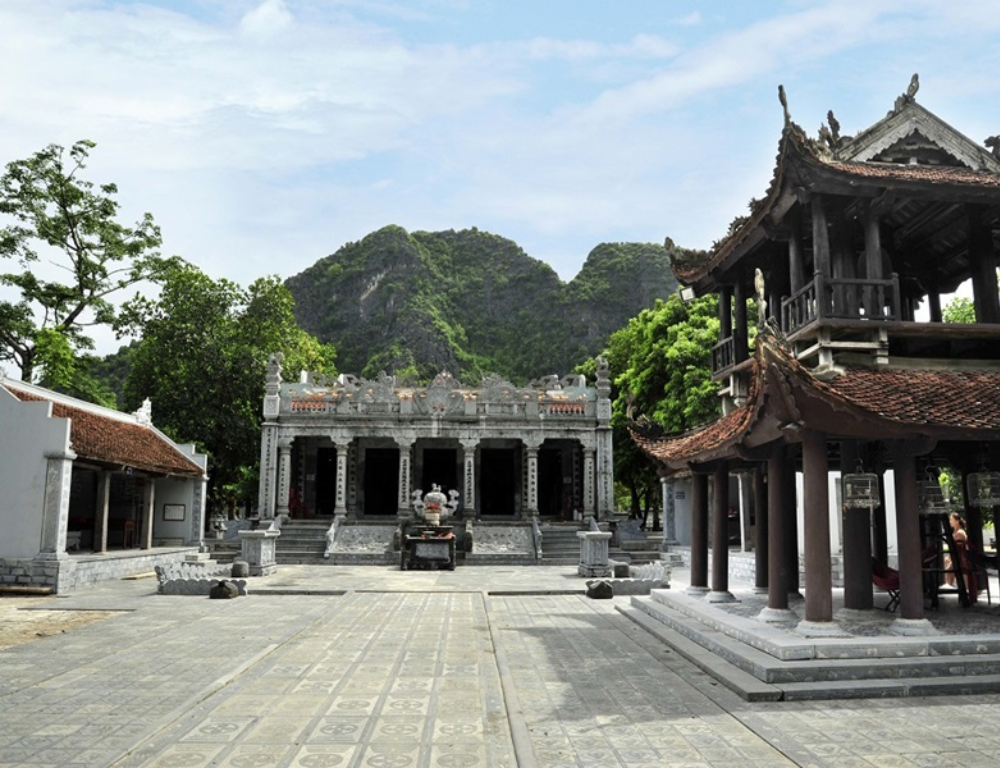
802, 430, 833, 625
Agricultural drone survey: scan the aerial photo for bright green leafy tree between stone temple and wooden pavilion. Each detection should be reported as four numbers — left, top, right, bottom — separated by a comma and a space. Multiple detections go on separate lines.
588, 295, 719, 516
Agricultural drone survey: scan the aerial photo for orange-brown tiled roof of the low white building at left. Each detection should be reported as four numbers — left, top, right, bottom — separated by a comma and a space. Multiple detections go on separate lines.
6, 386, 204, 476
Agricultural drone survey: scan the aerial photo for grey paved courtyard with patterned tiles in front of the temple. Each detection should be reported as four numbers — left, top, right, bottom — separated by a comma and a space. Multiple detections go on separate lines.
0, 566, 1000, 768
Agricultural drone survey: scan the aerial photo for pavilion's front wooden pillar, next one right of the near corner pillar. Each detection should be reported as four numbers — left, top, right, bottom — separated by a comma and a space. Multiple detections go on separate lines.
892, 443, 924, 620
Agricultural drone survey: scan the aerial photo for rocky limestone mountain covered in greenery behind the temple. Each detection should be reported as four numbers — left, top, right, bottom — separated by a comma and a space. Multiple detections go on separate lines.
286, 226, 676, 382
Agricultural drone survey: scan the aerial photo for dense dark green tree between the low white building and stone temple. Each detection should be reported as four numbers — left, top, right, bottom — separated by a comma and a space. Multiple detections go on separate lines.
120, 265, 334, 509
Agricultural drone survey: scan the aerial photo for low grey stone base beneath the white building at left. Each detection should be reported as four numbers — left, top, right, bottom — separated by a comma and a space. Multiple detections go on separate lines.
0, 547, 198, 593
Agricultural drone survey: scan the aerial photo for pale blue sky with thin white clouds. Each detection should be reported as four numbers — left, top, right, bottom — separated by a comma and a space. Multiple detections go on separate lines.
0, 0, 1000, 360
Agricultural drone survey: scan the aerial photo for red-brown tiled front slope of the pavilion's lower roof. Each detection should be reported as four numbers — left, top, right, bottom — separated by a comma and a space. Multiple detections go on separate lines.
814, 368, 1000, 431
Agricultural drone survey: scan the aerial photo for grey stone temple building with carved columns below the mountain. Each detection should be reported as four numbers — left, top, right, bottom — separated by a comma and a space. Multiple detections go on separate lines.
254, 355, 613, 562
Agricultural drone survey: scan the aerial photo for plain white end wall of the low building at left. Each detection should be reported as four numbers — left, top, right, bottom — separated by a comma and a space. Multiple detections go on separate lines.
0, 389, 70, 558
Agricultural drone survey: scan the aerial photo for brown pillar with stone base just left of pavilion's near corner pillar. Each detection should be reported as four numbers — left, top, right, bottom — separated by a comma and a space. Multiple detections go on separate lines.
758, 443, 798, 624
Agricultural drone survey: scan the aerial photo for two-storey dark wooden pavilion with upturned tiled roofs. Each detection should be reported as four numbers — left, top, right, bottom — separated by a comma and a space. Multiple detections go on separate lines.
633, 75, 1000, 634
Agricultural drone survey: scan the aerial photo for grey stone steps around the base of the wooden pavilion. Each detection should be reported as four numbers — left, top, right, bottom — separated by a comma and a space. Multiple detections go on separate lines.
618, 590, 1000, 701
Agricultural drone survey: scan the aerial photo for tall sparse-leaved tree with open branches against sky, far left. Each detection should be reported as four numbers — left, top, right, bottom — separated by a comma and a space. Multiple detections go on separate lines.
0, 141, 177, 386
